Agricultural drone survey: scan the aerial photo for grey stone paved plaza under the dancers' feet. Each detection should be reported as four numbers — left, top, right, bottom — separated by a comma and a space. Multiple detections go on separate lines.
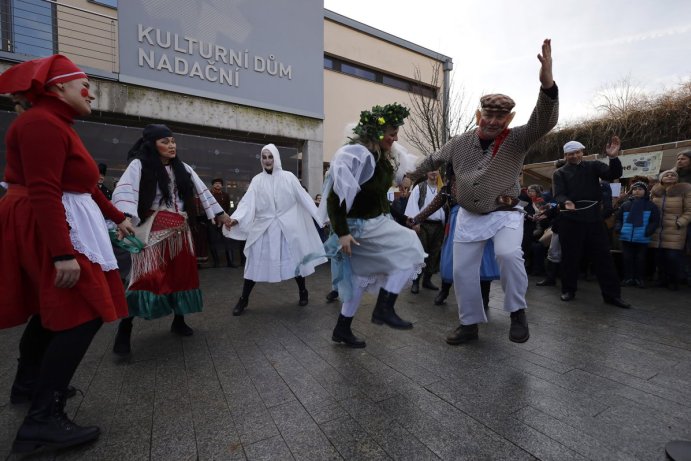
0, 265, 691, 461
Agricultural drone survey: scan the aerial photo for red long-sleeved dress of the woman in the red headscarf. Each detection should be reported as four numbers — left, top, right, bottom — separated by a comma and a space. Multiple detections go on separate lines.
0, 94, 127, 331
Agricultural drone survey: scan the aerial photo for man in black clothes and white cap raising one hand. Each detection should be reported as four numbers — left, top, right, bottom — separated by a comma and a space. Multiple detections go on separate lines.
552, 136, 631, 308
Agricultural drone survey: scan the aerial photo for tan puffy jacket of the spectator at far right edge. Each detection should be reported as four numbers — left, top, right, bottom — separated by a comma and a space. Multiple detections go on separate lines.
650, 183, 691, 250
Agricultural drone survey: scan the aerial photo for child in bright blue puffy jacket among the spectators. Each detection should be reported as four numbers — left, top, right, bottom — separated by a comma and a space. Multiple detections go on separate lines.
614, 182, 660, 288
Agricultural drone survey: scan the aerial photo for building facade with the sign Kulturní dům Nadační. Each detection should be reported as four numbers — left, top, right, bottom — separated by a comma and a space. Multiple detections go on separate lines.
0, 0, 452, 203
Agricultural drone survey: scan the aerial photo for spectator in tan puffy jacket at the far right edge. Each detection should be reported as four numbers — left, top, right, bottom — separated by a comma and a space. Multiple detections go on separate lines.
650, 170, 691, 290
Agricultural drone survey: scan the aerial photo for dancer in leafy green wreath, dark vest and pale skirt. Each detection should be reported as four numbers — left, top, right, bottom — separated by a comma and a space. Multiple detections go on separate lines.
322, 103, 427, 347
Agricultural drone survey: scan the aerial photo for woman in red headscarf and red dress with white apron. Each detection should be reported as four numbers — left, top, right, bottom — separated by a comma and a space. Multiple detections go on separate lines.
0, 55, 134, 453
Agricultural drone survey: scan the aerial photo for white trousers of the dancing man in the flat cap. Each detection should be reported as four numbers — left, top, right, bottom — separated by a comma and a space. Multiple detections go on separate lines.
453, 226, 528, 325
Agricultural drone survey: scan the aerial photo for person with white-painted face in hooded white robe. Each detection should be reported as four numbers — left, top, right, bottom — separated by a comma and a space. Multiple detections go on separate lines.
223, 144, 326, 315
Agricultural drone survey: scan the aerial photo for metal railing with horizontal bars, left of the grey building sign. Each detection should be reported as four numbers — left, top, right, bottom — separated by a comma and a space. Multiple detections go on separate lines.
0, 0, 118, 72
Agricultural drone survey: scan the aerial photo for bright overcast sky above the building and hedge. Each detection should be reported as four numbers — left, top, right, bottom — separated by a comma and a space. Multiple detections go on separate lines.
324, 0, 691, 124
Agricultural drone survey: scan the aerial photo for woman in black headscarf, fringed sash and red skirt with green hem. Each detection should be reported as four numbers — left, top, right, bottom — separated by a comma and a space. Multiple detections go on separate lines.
113, 125, 230, 355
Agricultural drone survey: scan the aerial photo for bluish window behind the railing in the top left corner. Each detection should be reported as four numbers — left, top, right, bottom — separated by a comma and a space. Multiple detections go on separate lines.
0, 0, 58, 56
